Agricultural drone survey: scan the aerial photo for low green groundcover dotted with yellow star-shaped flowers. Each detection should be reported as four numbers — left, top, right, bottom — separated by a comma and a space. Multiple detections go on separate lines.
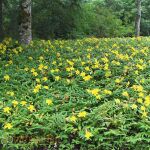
0, 37, 150, 150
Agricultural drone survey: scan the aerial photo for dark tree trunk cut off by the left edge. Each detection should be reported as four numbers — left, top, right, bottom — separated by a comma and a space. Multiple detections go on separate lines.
0, 0, 3, 42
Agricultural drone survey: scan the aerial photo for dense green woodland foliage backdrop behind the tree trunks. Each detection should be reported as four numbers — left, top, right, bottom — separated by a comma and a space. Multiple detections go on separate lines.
3, 0, 150, 39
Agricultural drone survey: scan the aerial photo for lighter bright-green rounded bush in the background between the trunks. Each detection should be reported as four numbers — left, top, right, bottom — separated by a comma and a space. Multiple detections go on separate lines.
72, 4, 134, 38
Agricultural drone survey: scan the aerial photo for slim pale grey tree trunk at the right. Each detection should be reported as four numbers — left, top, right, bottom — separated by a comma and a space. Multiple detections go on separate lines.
135, 0, 142, 37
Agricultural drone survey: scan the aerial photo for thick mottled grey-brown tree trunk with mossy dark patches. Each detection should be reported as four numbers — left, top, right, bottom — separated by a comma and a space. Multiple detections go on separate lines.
20, 0, 32, 44
